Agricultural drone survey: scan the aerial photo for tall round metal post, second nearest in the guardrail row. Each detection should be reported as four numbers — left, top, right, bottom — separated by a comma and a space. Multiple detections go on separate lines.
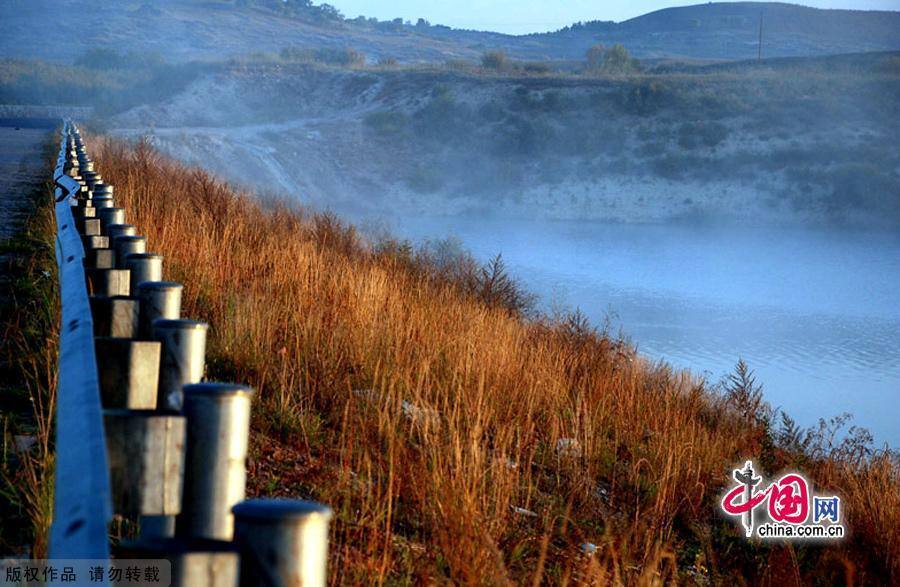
176, 383, 253, 540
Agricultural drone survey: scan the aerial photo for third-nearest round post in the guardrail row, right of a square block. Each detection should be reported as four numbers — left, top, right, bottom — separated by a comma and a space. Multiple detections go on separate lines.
153, 319, 209, 410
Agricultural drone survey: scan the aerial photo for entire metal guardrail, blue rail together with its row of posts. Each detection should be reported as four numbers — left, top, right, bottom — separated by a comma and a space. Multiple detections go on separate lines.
50, 120, 331, 587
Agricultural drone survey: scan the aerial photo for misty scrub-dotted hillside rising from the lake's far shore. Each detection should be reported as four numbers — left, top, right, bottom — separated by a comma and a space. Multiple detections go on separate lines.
103, 53, 900, 226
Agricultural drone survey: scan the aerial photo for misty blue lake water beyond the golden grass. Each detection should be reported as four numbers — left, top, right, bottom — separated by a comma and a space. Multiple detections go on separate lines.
368, 217, 900, 447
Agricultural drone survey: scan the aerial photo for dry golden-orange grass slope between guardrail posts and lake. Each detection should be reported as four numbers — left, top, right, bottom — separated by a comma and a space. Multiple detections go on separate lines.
91, 139, 900, 584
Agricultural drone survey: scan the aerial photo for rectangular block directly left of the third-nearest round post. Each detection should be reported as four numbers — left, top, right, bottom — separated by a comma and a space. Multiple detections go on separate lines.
94, 337, 160, 410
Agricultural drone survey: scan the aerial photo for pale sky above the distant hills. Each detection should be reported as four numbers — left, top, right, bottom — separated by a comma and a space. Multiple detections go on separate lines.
326, 0, 900, 34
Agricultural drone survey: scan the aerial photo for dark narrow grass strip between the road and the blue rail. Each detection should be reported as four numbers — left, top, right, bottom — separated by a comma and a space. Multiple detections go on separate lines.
0, 148, 60, 558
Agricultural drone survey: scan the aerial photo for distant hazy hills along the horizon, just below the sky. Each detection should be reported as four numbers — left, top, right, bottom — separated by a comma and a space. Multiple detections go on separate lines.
0, 0, 900, 62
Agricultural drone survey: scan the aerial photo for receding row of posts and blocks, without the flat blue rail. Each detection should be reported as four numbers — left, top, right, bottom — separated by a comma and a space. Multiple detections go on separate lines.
62, 125, 331, 587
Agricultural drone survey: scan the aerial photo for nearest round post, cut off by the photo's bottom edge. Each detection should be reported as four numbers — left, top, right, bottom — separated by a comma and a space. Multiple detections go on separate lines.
233, 499, 331, 587
